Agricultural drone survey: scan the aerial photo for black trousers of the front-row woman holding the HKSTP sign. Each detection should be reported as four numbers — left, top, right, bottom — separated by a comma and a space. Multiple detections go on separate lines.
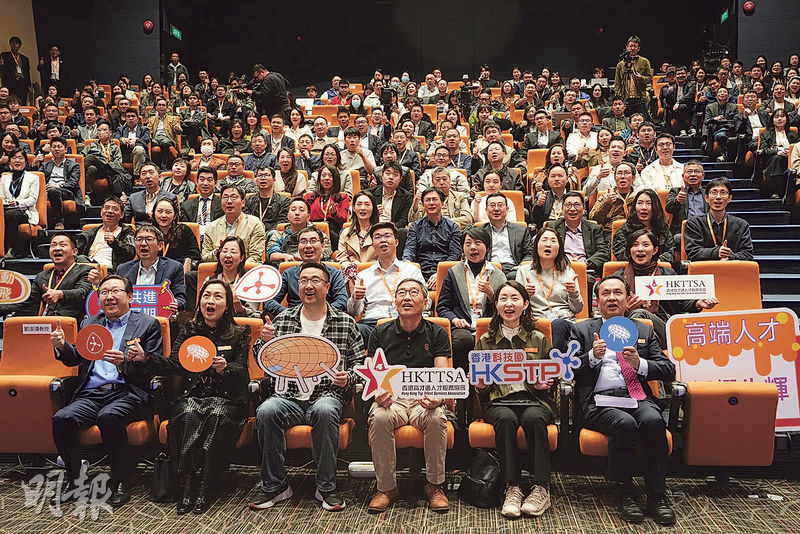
484, 404, 553, 486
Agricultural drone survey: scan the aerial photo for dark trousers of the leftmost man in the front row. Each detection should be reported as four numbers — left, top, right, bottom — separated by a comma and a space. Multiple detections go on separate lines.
53, 385, 153, 485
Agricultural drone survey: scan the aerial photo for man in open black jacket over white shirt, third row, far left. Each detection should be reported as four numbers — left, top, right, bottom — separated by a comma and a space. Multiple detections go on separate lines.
75, 197, 136, 272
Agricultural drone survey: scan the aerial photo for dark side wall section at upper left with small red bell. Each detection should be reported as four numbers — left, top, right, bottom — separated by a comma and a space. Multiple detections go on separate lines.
32, 0, 160, 92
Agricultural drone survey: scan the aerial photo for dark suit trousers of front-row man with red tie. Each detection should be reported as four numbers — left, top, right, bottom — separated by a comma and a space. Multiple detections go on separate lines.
583, 395, 668, 495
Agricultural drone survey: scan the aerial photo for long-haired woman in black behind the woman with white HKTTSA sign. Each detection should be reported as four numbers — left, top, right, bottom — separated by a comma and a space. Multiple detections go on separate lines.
611, 189, 675, 263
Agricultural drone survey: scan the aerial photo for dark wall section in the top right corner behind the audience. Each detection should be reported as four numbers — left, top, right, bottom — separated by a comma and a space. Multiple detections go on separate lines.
737, 0, 800, 67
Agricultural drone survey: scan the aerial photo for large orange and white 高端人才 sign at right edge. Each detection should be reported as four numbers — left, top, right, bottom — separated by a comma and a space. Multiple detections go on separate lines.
667, 308, 800, 430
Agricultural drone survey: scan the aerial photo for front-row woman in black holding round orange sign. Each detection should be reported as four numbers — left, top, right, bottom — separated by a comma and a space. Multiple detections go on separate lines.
149, 279, 250, 514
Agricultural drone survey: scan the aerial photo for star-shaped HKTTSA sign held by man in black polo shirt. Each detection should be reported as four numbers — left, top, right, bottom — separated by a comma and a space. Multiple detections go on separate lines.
354, 349, 469, 400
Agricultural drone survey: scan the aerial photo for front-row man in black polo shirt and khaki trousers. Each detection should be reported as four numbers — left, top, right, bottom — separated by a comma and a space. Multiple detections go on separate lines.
367, 278, 451, 512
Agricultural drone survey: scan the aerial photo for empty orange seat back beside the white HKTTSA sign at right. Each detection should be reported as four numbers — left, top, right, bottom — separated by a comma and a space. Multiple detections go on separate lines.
689, 261, 762, 312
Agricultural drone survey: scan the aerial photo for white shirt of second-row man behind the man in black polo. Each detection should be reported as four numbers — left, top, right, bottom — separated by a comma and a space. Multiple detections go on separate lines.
347, 258, 425, 321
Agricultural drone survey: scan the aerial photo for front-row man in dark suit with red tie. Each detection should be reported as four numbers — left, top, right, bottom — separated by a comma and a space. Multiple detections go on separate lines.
574, 275, 675, 525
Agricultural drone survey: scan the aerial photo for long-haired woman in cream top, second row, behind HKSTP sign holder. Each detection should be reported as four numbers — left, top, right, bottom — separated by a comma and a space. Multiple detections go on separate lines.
517, 227, 584, 321
